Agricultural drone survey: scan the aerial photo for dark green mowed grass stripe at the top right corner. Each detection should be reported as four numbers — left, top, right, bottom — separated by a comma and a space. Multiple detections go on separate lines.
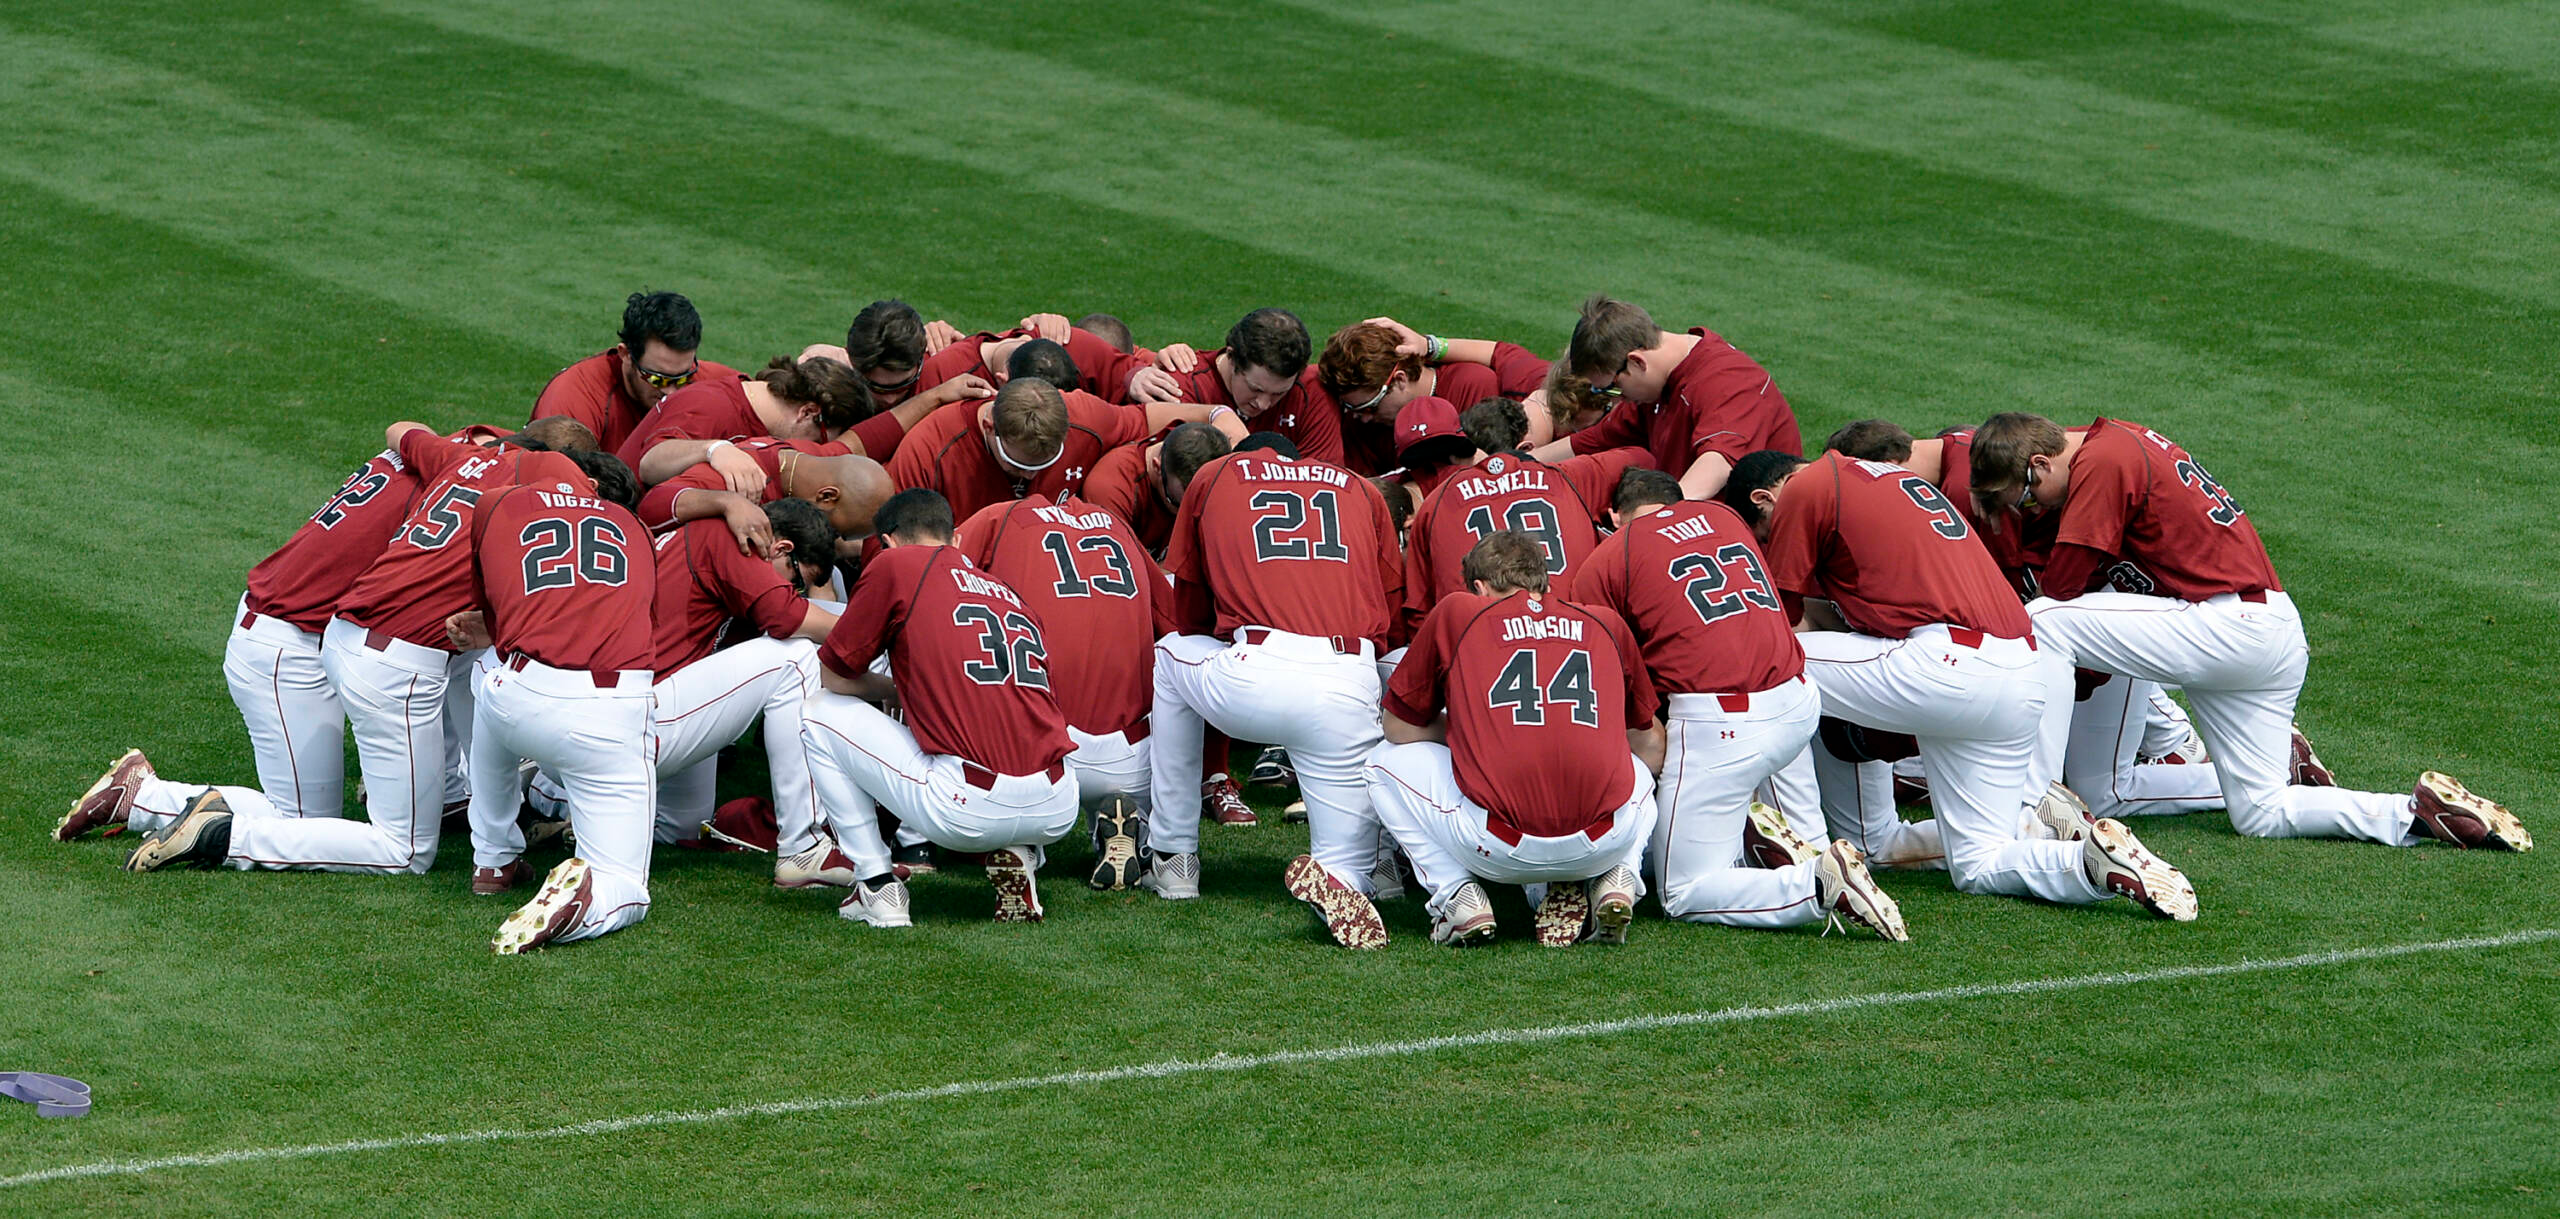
1822, 0, 2560, 192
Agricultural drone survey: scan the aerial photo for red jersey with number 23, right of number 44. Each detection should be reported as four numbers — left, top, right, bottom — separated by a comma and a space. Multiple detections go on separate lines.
1572, 499, 1805, 694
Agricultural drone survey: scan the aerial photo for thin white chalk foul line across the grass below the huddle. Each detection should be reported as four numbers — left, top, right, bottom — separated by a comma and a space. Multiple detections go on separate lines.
0, 927, 2560, 1188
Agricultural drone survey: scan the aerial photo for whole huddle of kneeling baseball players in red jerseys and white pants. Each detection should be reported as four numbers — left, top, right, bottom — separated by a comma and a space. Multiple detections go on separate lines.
56, 292, 2532, 953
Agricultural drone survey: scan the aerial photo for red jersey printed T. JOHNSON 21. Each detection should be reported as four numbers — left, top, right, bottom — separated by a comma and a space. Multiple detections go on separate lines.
1165, 451, 1405, 648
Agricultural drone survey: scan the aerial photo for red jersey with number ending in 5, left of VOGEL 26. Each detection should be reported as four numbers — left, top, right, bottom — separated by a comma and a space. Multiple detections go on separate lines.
338, 428, 593, 653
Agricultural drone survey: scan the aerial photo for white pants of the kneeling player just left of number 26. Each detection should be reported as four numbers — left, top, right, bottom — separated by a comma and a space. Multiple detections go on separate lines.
225, 617, 448, 873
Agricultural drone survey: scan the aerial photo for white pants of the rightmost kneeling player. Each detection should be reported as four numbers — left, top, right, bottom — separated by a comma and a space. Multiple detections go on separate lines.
2017, 592, 2417, 845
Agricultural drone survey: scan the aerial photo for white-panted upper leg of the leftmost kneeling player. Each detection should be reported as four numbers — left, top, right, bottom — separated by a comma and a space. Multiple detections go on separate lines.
223, 597, 346, 817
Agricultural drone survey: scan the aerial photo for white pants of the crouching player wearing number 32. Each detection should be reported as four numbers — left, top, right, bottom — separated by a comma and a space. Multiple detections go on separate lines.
801, 689, 1083, 876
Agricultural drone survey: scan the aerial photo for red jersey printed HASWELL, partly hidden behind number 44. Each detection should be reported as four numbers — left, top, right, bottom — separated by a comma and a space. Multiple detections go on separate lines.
1405, 448, 1646, 622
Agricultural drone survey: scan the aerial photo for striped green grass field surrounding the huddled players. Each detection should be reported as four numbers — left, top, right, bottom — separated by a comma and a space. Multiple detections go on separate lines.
0, 0, 2560, 1216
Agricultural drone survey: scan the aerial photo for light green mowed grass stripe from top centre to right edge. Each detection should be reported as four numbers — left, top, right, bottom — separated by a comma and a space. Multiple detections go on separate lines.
1288, 0, 2560, 307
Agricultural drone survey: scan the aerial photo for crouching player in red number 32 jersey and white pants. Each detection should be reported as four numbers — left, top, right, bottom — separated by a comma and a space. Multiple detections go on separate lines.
801, 487, 1078, 927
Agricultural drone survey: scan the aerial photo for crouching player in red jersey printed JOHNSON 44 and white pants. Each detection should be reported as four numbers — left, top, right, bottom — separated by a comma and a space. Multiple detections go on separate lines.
1367, 530, 1661, 948
